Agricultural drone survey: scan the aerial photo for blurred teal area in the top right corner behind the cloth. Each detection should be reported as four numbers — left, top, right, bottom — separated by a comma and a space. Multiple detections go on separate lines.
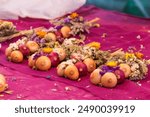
86, 0, 150, 18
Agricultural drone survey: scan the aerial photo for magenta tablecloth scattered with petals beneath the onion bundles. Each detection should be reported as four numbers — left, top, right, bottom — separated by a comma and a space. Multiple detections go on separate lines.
0, 6, 150, 100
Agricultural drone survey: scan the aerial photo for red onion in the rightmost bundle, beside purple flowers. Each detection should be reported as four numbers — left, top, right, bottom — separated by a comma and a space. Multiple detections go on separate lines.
115, 69, 125, 84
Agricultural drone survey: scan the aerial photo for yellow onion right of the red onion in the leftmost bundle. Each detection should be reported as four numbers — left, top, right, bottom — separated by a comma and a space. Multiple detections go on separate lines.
26, 41, 39, 53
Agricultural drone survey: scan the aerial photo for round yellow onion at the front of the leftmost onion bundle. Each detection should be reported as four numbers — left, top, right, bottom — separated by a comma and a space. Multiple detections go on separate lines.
10, 50, 23, 63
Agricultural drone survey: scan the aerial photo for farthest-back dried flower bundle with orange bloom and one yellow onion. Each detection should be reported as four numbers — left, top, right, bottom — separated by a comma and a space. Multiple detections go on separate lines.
50, 13, 100, 38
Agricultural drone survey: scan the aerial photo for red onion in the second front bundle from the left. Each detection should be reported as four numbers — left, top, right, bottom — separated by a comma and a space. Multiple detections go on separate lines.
48, 52, 60, 67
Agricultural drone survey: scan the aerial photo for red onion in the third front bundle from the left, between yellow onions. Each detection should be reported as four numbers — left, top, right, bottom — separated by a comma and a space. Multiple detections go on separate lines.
75, 61, 88, 76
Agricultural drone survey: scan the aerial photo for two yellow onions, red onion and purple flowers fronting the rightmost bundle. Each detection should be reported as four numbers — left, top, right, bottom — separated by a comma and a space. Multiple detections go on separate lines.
90, 66, 125, 88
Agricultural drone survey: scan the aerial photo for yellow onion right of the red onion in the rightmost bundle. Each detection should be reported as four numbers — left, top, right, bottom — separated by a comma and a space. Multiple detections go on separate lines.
119, 64, 131, 78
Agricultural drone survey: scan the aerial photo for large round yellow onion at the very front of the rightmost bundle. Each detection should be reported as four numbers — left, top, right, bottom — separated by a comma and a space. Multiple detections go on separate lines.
101, 72, 117, 88
